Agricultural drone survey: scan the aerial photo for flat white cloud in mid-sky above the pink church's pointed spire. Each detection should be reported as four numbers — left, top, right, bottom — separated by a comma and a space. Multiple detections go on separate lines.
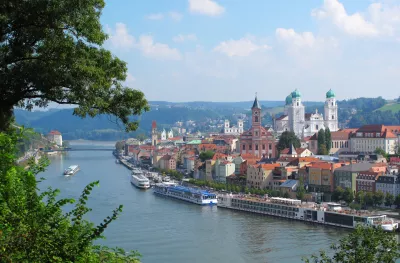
214, 38, 270, 57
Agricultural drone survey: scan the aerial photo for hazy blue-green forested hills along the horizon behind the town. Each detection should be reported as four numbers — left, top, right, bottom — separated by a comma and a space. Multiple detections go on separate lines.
15, 97, 400, 140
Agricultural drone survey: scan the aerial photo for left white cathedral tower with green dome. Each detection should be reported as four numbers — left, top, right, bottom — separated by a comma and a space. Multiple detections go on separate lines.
288, 89, 305, 138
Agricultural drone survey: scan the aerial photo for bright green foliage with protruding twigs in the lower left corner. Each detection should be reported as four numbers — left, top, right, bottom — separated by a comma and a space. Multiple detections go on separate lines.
0, 130, 138, 262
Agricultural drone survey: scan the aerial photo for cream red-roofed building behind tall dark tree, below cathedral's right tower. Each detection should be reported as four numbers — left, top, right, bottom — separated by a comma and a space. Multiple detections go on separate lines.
309, 131, 350, 155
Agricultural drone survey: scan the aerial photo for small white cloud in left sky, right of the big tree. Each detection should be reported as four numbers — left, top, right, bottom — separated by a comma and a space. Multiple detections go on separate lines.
137, 35, 182, 60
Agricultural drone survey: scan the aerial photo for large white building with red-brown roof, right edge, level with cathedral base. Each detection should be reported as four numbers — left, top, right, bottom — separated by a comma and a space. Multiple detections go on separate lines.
350, 124, 398, 154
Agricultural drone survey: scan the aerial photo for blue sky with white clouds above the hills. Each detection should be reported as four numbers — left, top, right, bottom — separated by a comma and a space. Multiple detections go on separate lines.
101, 0, 400, 102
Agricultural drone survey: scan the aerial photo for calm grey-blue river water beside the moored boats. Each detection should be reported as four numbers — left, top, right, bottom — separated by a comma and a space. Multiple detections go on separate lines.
39, 142, 349, 263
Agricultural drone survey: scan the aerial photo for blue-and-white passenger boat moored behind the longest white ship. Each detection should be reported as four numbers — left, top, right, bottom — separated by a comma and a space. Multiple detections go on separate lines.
154, 182, 218, 205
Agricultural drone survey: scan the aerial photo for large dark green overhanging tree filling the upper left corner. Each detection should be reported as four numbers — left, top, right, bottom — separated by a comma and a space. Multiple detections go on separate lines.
0, 0, 149, 131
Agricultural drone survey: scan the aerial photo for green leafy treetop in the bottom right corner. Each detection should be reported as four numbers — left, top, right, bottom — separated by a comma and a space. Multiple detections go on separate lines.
303, 225, 400, 263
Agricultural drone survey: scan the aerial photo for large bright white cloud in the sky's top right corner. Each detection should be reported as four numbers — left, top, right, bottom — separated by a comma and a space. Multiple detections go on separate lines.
311, 0, 400, 37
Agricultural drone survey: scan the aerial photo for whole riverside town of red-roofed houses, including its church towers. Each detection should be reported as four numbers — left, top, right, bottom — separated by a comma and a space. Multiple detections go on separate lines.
117, 90, 400, 205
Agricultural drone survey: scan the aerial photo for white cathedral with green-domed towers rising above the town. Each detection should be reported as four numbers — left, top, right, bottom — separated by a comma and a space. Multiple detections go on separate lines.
274, 89, 339, 138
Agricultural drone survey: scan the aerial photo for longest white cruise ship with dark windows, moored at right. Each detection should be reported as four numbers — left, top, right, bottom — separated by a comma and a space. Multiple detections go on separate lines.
218, 194, 398, 231
